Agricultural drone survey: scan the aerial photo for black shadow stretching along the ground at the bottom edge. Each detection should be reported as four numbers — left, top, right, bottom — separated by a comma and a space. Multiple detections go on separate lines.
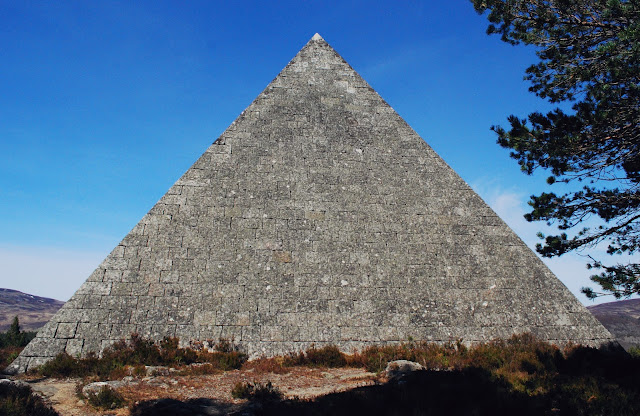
132, 368, 638, 416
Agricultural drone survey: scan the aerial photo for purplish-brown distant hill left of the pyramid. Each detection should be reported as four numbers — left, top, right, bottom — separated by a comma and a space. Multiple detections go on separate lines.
0, 288, 64, 331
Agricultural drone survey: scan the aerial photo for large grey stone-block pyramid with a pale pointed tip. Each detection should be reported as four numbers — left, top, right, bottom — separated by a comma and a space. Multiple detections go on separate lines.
9, 35, 612, 371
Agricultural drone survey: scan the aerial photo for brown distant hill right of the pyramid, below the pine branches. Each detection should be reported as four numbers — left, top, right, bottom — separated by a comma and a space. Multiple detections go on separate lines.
587, 299, 640, 348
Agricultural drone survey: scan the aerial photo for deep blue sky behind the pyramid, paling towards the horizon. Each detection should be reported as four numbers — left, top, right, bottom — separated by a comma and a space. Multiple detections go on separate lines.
0, 0, 632, 303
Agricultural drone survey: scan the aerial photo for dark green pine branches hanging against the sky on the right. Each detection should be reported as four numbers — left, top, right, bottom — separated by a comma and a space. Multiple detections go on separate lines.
473, 0, 640, 298
